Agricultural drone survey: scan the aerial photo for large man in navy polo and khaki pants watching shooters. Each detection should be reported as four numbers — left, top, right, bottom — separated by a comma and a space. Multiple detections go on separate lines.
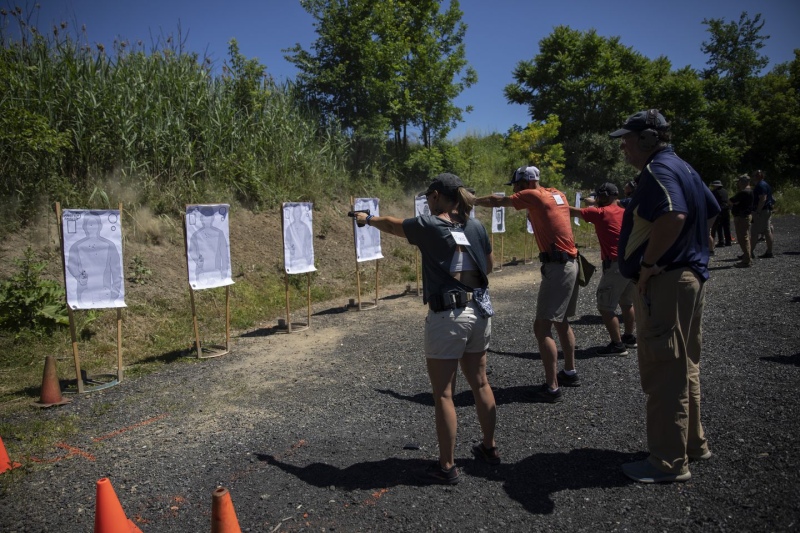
611, 109, 720, 483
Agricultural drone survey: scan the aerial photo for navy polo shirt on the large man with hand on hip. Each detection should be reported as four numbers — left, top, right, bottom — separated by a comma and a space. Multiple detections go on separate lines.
618, 146, 720, 280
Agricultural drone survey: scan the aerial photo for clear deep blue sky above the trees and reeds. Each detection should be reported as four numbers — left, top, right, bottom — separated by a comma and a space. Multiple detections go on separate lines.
25, 0, 800, 137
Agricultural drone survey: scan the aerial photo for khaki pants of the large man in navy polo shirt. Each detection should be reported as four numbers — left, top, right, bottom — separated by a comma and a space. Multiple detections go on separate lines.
634, 268, 708, 474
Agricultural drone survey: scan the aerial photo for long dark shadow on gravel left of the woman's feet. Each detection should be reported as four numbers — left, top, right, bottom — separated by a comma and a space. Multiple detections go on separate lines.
256, 453, 438, 490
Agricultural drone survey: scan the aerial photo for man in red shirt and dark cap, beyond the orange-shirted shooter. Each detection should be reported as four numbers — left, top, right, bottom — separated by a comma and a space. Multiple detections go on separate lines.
569, 183, 636, 355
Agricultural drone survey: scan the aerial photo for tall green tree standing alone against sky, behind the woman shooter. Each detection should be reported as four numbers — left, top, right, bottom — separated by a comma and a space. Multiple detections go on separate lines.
286, 0, 477, 161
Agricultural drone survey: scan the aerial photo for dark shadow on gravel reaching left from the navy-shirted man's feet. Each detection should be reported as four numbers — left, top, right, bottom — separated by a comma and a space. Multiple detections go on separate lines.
464, 448, 647, 514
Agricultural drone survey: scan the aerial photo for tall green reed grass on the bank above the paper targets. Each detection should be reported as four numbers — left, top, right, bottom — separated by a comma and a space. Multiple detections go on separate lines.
0, 8, 351, 229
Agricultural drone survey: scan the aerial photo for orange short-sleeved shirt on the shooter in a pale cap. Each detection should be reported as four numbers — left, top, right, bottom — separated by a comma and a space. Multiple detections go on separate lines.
510, 187, 578, 257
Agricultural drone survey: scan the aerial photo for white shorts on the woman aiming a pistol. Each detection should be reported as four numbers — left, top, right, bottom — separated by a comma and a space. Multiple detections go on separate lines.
425, 302, 492, 359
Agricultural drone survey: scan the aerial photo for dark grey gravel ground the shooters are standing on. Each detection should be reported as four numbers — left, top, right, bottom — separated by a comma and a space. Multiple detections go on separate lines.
0, 217, 800, 533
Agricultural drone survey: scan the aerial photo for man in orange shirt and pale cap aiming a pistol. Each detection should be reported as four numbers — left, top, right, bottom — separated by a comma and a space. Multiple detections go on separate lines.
475, 166, 580, 403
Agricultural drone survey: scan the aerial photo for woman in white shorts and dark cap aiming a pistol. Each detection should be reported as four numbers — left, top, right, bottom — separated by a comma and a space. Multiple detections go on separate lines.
354, 174, 500, 485
